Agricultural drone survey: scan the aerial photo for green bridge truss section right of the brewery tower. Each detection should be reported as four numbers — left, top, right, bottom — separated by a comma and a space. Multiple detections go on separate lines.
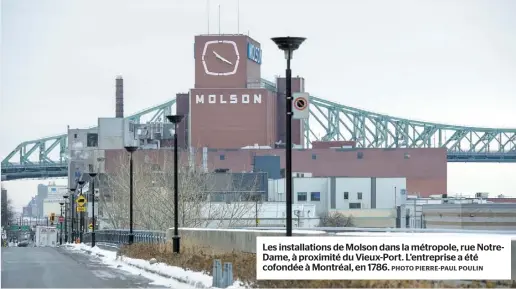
304, 96, 516, 162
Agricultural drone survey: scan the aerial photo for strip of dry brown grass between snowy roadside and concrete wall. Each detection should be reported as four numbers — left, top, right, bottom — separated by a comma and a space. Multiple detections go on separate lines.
120, 239, 516, 288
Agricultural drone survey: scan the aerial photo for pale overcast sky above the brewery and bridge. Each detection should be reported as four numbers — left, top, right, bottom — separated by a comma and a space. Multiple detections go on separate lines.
0, 0, 516, 207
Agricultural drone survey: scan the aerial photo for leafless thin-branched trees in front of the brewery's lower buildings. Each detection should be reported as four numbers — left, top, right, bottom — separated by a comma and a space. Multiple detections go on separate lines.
100, 150, 259, 230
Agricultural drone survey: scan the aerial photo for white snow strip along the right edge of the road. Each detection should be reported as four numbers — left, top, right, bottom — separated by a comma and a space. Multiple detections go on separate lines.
63, 244, 244, 289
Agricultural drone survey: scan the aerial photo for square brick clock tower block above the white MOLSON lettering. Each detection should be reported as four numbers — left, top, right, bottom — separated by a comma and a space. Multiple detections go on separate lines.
194, 34, 262, 88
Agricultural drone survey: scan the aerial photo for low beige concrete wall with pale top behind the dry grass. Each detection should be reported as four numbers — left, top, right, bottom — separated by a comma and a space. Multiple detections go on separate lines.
167, 228, 328, 253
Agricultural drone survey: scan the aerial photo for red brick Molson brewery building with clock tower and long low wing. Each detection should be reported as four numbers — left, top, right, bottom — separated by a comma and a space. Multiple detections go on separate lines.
106, 35, 447, 196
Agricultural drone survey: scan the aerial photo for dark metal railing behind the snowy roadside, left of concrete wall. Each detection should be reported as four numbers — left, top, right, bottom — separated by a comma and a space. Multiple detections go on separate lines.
83, 229, 167, 245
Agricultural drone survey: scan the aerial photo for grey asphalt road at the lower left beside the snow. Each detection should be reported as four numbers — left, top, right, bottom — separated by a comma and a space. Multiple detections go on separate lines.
2, 247, 163, 288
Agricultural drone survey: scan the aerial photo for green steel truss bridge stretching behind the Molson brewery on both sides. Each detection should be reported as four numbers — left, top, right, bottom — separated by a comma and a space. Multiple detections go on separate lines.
2, 81, 516, 180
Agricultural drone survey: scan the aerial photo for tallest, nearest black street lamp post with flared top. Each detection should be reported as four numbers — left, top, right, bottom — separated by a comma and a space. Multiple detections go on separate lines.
271, 37, 306, 236
